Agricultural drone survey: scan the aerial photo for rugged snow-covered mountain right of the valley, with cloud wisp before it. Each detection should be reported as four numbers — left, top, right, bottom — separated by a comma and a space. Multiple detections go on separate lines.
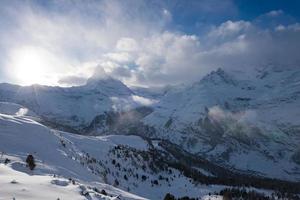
143, 67, 300, 181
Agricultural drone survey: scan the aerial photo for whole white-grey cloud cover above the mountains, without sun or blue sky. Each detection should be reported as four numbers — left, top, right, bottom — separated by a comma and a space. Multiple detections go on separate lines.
0, 0, 300, 86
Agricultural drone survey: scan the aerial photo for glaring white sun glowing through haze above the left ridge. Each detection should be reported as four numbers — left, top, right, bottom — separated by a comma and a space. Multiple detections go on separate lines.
10, 46, 57, 85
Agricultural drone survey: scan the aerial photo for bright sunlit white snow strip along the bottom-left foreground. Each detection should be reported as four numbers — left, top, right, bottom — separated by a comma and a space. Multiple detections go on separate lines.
0, 162, 144, 200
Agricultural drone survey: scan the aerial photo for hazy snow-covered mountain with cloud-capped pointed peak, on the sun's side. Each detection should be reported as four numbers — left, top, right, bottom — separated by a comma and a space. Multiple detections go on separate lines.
0, 76, 152, 131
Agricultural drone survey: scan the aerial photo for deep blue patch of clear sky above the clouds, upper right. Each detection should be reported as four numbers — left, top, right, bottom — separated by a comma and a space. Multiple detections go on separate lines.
162, 0, 300, 33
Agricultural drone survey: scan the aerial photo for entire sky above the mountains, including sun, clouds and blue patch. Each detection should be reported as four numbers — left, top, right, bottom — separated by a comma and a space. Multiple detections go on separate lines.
0, 0, 300, 87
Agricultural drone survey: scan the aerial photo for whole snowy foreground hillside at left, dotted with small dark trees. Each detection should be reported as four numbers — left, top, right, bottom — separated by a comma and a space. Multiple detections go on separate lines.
0, 108, 227, 199
